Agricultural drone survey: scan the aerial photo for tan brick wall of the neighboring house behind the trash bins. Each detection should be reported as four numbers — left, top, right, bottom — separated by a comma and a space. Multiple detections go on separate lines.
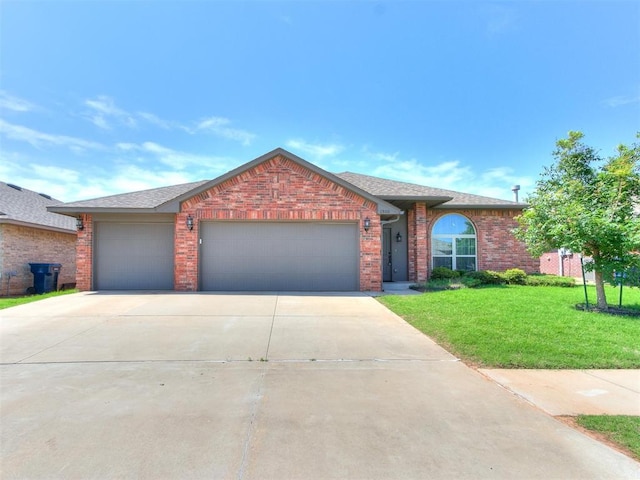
0, 223, 76, 296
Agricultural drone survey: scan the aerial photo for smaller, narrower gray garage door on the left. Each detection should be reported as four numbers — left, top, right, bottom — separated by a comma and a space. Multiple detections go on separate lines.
94, 223, 173, 290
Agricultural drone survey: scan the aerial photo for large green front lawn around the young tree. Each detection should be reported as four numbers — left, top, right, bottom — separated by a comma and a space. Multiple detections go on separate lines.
380, 286, 640, 369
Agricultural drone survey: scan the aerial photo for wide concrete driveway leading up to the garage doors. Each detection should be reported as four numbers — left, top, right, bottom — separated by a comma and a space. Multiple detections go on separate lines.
0, 293, 640, 479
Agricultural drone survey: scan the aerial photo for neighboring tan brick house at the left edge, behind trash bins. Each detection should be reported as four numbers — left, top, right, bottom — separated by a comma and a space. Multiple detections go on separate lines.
0, 182, 76, 296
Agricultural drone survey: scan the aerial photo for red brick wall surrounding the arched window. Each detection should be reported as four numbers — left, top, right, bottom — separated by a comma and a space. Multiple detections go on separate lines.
427, 209, 540, 273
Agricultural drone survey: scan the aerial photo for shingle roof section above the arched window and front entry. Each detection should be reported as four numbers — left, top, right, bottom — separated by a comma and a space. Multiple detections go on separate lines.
336, 172, 525, 208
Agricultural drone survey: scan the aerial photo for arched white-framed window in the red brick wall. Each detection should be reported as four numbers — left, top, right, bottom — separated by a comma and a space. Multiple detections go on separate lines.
431, 213, 478, 271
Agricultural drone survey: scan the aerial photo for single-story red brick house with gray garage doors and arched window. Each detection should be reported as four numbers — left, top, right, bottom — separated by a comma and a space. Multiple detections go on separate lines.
49, 149, 539, 291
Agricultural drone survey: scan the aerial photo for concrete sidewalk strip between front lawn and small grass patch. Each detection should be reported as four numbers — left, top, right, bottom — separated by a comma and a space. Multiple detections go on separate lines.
479, 369, 640, 416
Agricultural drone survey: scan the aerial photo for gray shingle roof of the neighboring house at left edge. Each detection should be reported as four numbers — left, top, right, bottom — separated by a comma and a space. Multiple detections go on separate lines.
0, 182, 76, 233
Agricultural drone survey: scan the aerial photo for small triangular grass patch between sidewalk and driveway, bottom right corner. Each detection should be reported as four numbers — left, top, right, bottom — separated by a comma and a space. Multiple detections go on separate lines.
576, 415, 640, 460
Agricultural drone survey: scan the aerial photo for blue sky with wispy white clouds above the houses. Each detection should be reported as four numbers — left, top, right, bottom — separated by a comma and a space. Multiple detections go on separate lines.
0, 0, 640, 201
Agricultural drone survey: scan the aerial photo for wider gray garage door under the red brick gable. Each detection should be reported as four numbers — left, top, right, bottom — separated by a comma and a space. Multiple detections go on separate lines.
200, 222, 360, 291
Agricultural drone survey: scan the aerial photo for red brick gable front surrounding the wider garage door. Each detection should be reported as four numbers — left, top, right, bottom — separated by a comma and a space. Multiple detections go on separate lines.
175, 155, 382, 291
